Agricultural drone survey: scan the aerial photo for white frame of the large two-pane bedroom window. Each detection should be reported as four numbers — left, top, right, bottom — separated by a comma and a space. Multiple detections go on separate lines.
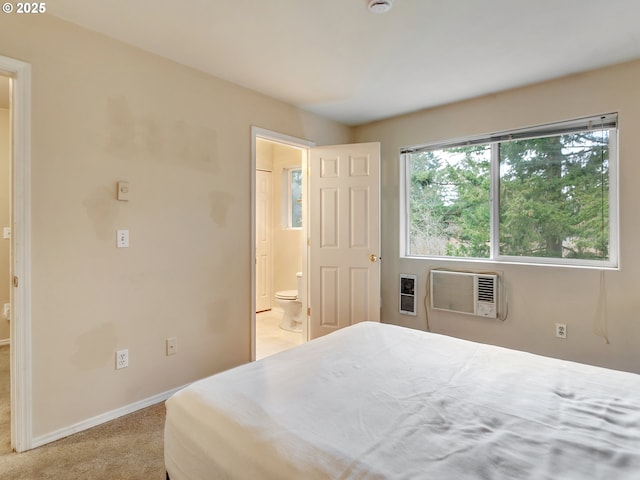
399, 114, 620, 269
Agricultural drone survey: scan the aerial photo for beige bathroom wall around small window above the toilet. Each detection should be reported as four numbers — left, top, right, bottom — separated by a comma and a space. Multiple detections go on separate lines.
273, 143, 303, 293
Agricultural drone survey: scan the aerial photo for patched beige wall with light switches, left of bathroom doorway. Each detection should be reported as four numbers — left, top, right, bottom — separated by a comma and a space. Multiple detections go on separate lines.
0, 15, 351, 438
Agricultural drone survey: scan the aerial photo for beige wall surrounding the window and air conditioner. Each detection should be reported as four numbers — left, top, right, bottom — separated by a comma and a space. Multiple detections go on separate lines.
356, 62, 640, 372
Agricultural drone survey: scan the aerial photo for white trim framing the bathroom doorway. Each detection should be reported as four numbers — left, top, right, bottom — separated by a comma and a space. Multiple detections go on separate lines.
249, 126, 315, 361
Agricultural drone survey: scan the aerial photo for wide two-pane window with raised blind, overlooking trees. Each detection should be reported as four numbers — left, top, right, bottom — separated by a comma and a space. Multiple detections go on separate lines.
402, 114, 618, 267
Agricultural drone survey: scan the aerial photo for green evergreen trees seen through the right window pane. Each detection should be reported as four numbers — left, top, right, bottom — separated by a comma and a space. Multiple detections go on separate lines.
500, 132, 609, 259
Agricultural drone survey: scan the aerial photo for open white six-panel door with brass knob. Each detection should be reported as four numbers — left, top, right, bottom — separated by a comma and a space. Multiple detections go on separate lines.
309, 143, 380, 338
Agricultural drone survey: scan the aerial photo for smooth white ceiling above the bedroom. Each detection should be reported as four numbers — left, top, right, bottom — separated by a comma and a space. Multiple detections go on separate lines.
42, 0, 640, 125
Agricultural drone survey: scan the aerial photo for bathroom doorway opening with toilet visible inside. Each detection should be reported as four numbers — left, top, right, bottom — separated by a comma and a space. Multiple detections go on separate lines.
251, 127, 312, 360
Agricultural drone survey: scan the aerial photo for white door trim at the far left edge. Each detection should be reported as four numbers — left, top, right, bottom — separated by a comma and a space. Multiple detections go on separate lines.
0, 56, 33, 452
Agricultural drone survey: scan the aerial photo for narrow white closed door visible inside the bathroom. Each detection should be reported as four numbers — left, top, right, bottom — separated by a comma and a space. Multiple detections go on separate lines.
256, 170, 273, 312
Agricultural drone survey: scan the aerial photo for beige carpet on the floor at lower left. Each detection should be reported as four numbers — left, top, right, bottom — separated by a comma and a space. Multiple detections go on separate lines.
0, 347, 165, 480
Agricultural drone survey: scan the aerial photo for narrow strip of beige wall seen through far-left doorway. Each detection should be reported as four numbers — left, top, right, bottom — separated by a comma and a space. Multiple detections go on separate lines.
0, 109, 11, 340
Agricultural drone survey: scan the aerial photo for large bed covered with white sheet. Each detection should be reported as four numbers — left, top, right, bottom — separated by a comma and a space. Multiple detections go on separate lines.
165, 322, 640, 480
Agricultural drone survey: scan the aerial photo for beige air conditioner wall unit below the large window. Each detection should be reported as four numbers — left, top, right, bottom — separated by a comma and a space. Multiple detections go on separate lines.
429, 270, 500, 318
